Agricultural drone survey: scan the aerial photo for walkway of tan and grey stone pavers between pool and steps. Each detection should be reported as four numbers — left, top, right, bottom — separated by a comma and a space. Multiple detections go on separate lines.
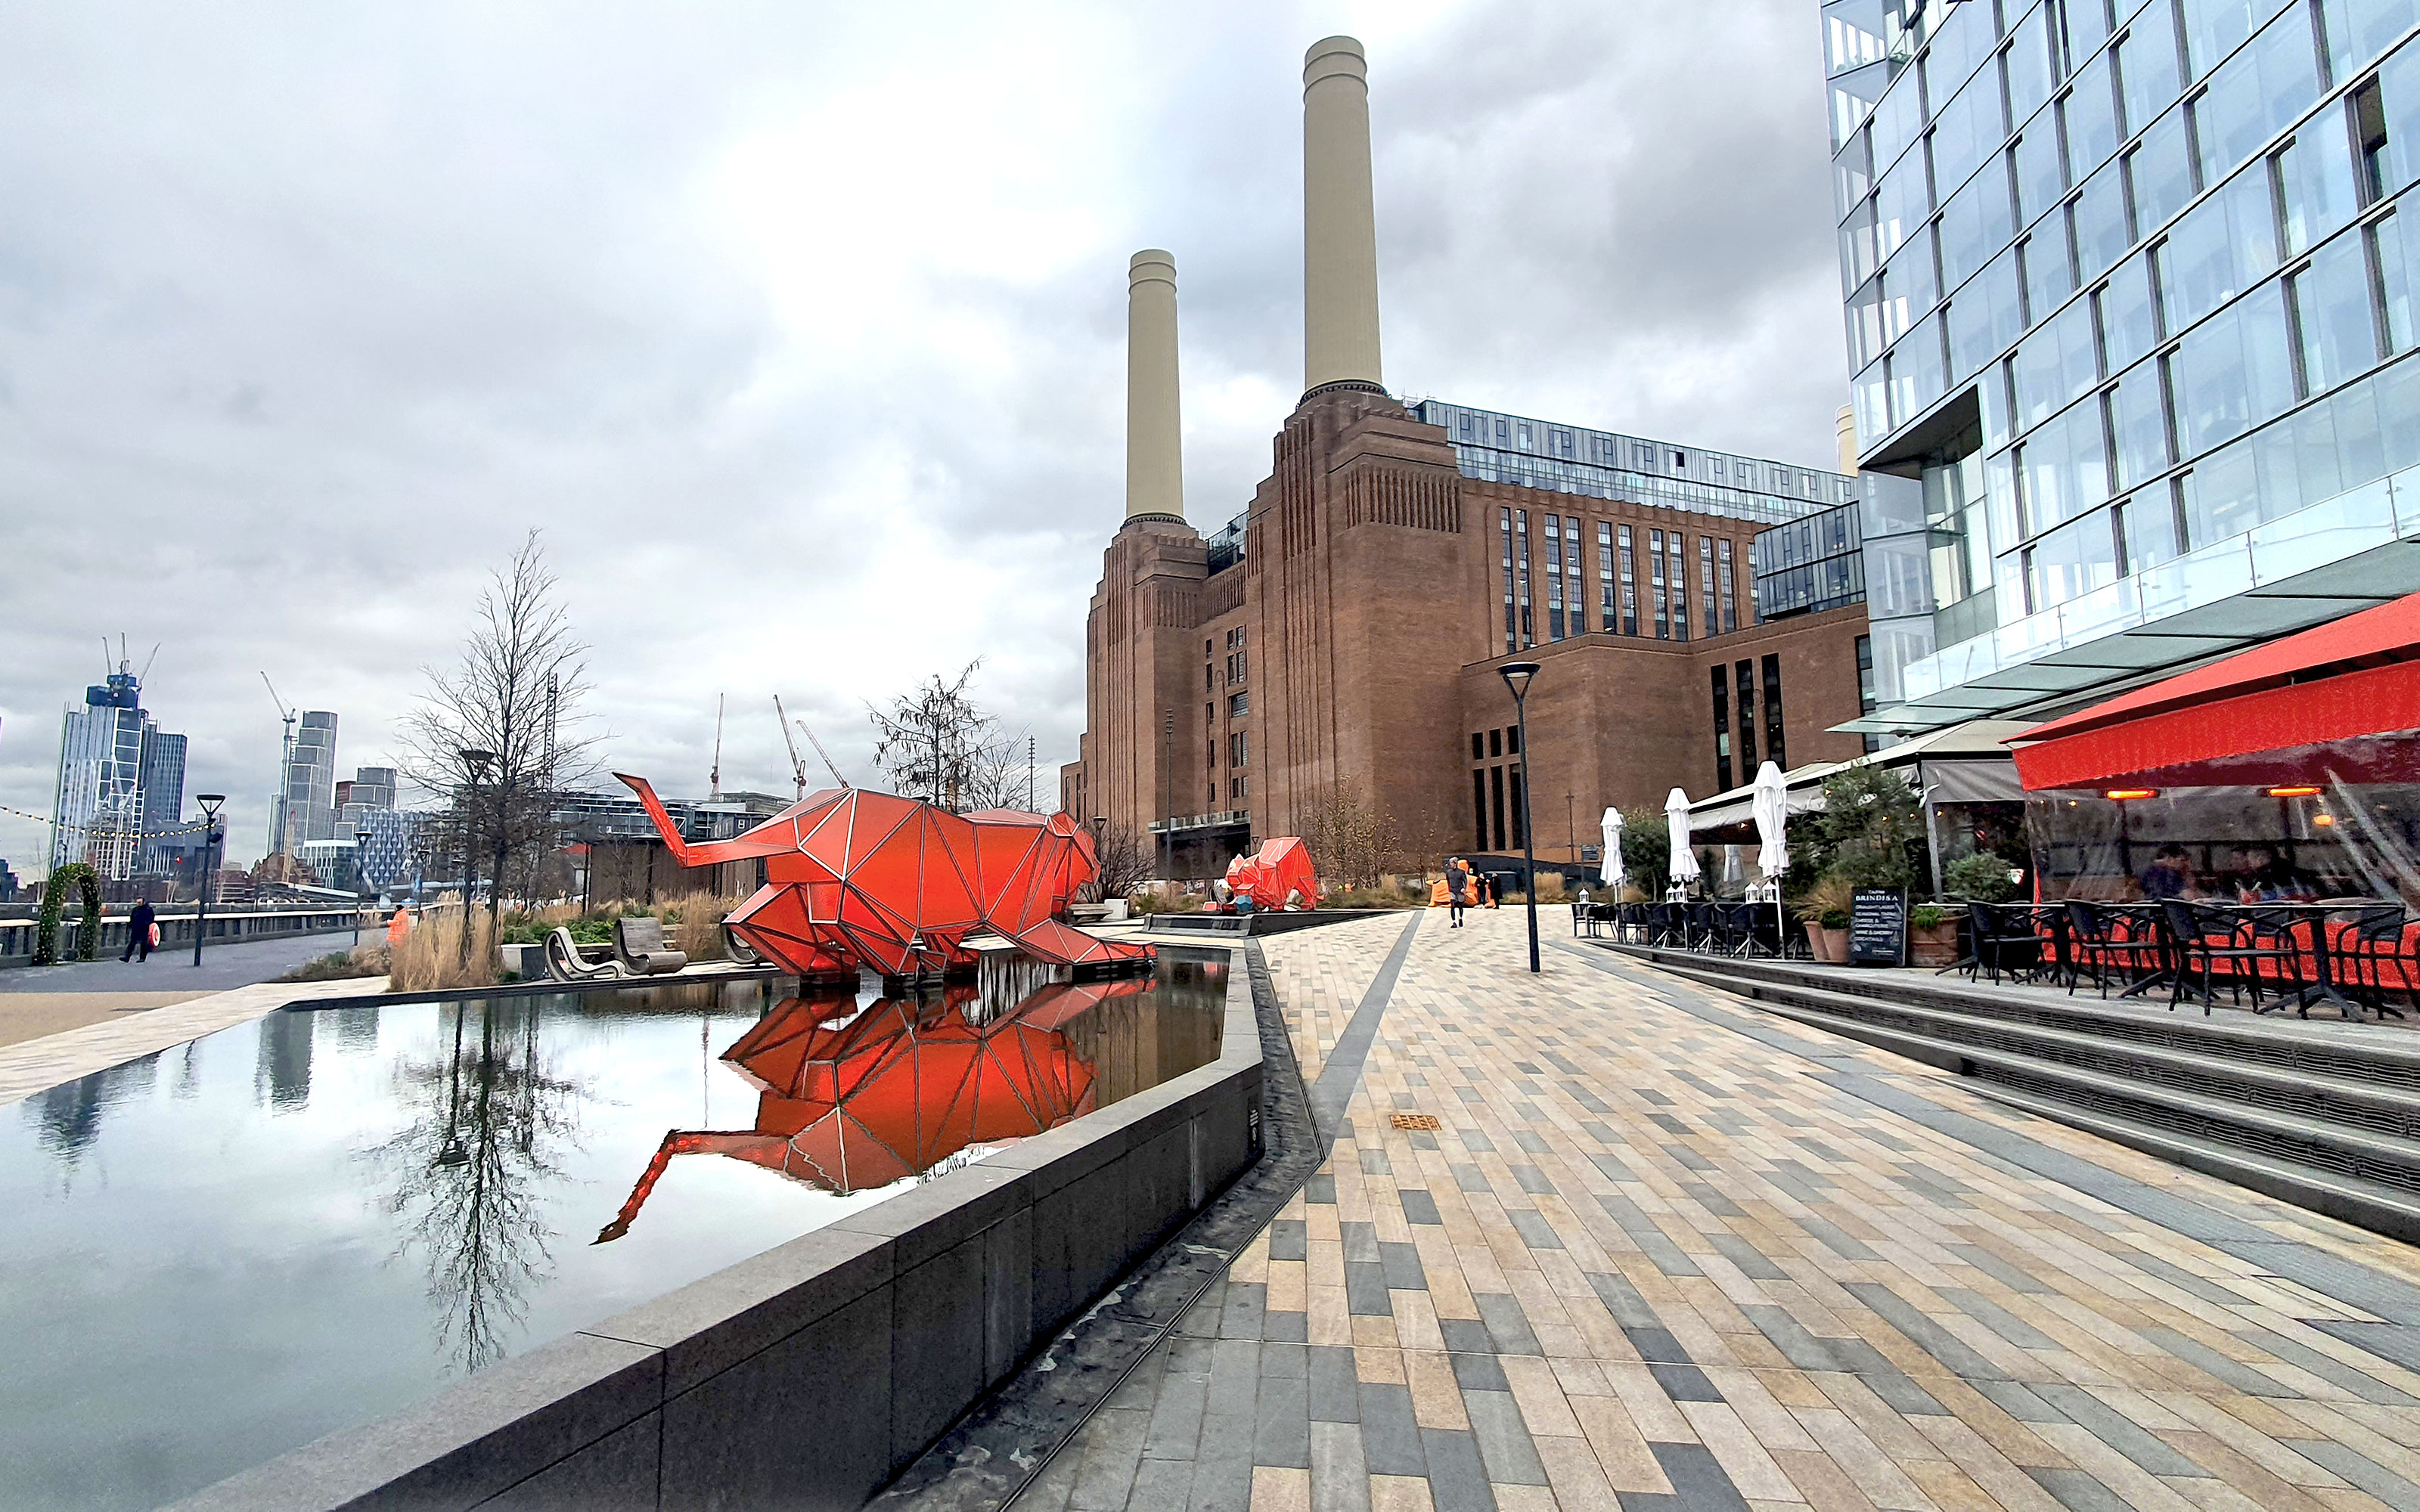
1019, 909, 2420, 1512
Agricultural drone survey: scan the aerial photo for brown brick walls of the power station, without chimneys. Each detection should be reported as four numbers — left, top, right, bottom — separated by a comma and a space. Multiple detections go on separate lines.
1060, 389, 1866, 875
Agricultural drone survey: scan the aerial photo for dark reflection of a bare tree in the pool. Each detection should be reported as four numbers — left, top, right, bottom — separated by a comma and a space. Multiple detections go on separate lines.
375, 1002, 588, 1374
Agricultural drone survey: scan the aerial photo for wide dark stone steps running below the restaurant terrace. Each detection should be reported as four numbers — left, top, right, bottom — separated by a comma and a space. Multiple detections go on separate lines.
1597, 941, 2420, 1244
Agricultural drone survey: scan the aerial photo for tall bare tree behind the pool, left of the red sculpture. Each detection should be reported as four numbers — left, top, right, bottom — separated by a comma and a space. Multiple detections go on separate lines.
402, 530, 597, 919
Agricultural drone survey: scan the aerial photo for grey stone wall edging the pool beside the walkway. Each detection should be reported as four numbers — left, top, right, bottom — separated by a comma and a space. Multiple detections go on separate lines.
174, 941, 1263, 1512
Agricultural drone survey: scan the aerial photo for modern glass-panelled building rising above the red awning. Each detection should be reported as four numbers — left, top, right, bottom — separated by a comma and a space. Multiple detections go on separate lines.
1823, 0, 2420, 733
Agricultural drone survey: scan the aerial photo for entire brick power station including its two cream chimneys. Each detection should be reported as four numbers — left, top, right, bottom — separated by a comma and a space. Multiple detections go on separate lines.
1060, 36, 1871, 878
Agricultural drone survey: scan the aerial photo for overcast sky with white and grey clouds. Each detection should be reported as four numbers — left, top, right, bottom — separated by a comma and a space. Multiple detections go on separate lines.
0, 0, 1847, 871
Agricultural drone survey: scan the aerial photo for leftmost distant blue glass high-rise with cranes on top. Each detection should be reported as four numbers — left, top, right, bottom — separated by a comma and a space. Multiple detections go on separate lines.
51, 663, 184, 881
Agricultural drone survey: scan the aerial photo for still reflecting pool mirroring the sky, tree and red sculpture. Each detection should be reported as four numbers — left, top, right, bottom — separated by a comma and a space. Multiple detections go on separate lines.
0, 958, 1224, 1507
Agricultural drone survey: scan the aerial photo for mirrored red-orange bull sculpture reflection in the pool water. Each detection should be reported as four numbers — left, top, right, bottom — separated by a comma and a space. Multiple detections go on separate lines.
595, 978, 1152, 1244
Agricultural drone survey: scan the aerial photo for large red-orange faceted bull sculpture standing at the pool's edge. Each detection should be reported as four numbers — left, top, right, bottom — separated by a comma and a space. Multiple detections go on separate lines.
615, 772, 1154, 978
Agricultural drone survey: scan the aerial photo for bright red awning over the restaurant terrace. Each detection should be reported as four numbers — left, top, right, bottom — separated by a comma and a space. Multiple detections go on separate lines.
2011, 593, 2420, 794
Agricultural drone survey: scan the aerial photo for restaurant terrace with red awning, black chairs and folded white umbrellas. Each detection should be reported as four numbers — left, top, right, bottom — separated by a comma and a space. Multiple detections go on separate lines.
1573, 583, 2420, 1021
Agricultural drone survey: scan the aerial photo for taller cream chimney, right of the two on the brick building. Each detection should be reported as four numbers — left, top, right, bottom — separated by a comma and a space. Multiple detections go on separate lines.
1302, 36, 1387, 392
